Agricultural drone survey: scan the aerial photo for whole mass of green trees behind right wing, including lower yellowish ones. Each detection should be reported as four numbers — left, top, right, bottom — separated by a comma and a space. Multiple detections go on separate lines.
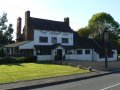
77, 12, 120, 50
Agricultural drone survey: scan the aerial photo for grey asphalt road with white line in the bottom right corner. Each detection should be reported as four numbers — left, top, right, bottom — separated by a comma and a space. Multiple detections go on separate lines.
31, 73, 120, 90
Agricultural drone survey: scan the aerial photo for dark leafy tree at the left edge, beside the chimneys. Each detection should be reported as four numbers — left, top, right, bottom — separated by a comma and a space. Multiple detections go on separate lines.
0, 13, 14, 44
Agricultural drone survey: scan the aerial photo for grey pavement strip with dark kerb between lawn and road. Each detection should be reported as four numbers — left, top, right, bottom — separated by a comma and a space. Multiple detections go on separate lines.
0, 65, 120, 90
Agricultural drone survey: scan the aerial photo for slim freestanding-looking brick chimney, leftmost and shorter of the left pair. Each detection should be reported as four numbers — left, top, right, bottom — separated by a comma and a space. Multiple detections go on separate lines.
16, 17, 22, 42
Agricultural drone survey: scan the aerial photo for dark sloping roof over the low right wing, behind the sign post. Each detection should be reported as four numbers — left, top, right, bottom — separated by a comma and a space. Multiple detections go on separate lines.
73, 32, 116, 52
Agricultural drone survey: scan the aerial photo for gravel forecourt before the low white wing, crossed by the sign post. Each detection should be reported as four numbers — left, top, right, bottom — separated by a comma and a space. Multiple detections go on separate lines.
66, 60, 120, 71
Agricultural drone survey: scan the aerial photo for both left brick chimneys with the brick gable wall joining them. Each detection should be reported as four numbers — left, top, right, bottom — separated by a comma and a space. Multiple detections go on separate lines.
16, 11, 34, 42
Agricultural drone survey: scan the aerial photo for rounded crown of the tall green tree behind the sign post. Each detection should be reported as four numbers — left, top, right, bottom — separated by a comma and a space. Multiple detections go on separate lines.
88, 12, 120, 37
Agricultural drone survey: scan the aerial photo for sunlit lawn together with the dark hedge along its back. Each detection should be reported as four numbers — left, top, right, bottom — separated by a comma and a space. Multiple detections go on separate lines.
0, 49, 89, 84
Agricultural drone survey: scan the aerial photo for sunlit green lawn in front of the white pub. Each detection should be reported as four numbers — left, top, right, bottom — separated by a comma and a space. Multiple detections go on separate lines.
0, 63, 89, 83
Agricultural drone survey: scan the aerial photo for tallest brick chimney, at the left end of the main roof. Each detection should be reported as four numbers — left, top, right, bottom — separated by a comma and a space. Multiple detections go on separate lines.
24, 11, 31, 40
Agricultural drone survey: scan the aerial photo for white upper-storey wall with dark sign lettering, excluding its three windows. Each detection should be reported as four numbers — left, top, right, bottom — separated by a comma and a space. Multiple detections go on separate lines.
34, 30, 73, 45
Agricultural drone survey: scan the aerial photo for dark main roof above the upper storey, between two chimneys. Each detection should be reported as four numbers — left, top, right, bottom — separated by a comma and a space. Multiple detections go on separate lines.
30, 17, 73, 32
